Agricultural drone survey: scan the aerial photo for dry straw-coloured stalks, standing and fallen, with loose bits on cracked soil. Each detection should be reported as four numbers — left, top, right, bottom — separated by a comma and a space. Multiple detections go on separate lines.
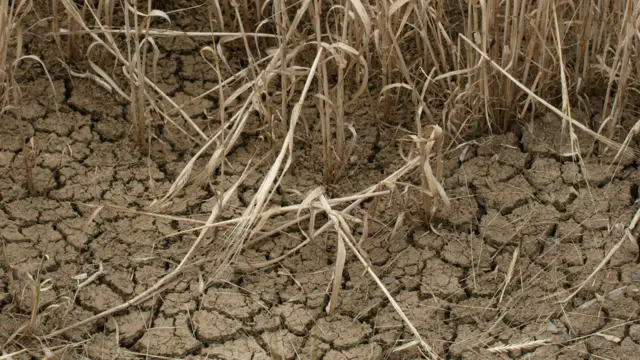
0, 0, 640, 358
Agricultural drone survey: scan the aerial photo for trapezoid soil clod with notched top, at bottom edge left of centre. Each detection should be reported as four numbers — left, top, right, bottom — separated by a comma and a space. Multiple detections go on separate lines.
134, 314, 202, 356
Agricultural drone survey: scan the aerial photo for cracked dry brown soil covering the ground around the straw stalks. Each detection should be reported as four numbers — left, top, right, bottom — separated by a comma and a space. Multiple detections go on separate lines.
0, 4, 640, 360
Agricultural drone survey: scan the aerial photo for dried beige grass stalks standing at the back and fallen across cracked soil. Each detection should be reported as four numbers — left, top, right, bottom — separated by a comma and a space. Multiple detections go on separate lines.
0, 0, 640, 358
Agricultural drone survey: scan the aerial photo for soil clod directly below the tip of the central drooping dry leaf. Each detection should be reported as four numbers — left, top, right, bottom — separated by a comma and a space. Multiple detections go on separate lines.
311, 315, 372, 349
